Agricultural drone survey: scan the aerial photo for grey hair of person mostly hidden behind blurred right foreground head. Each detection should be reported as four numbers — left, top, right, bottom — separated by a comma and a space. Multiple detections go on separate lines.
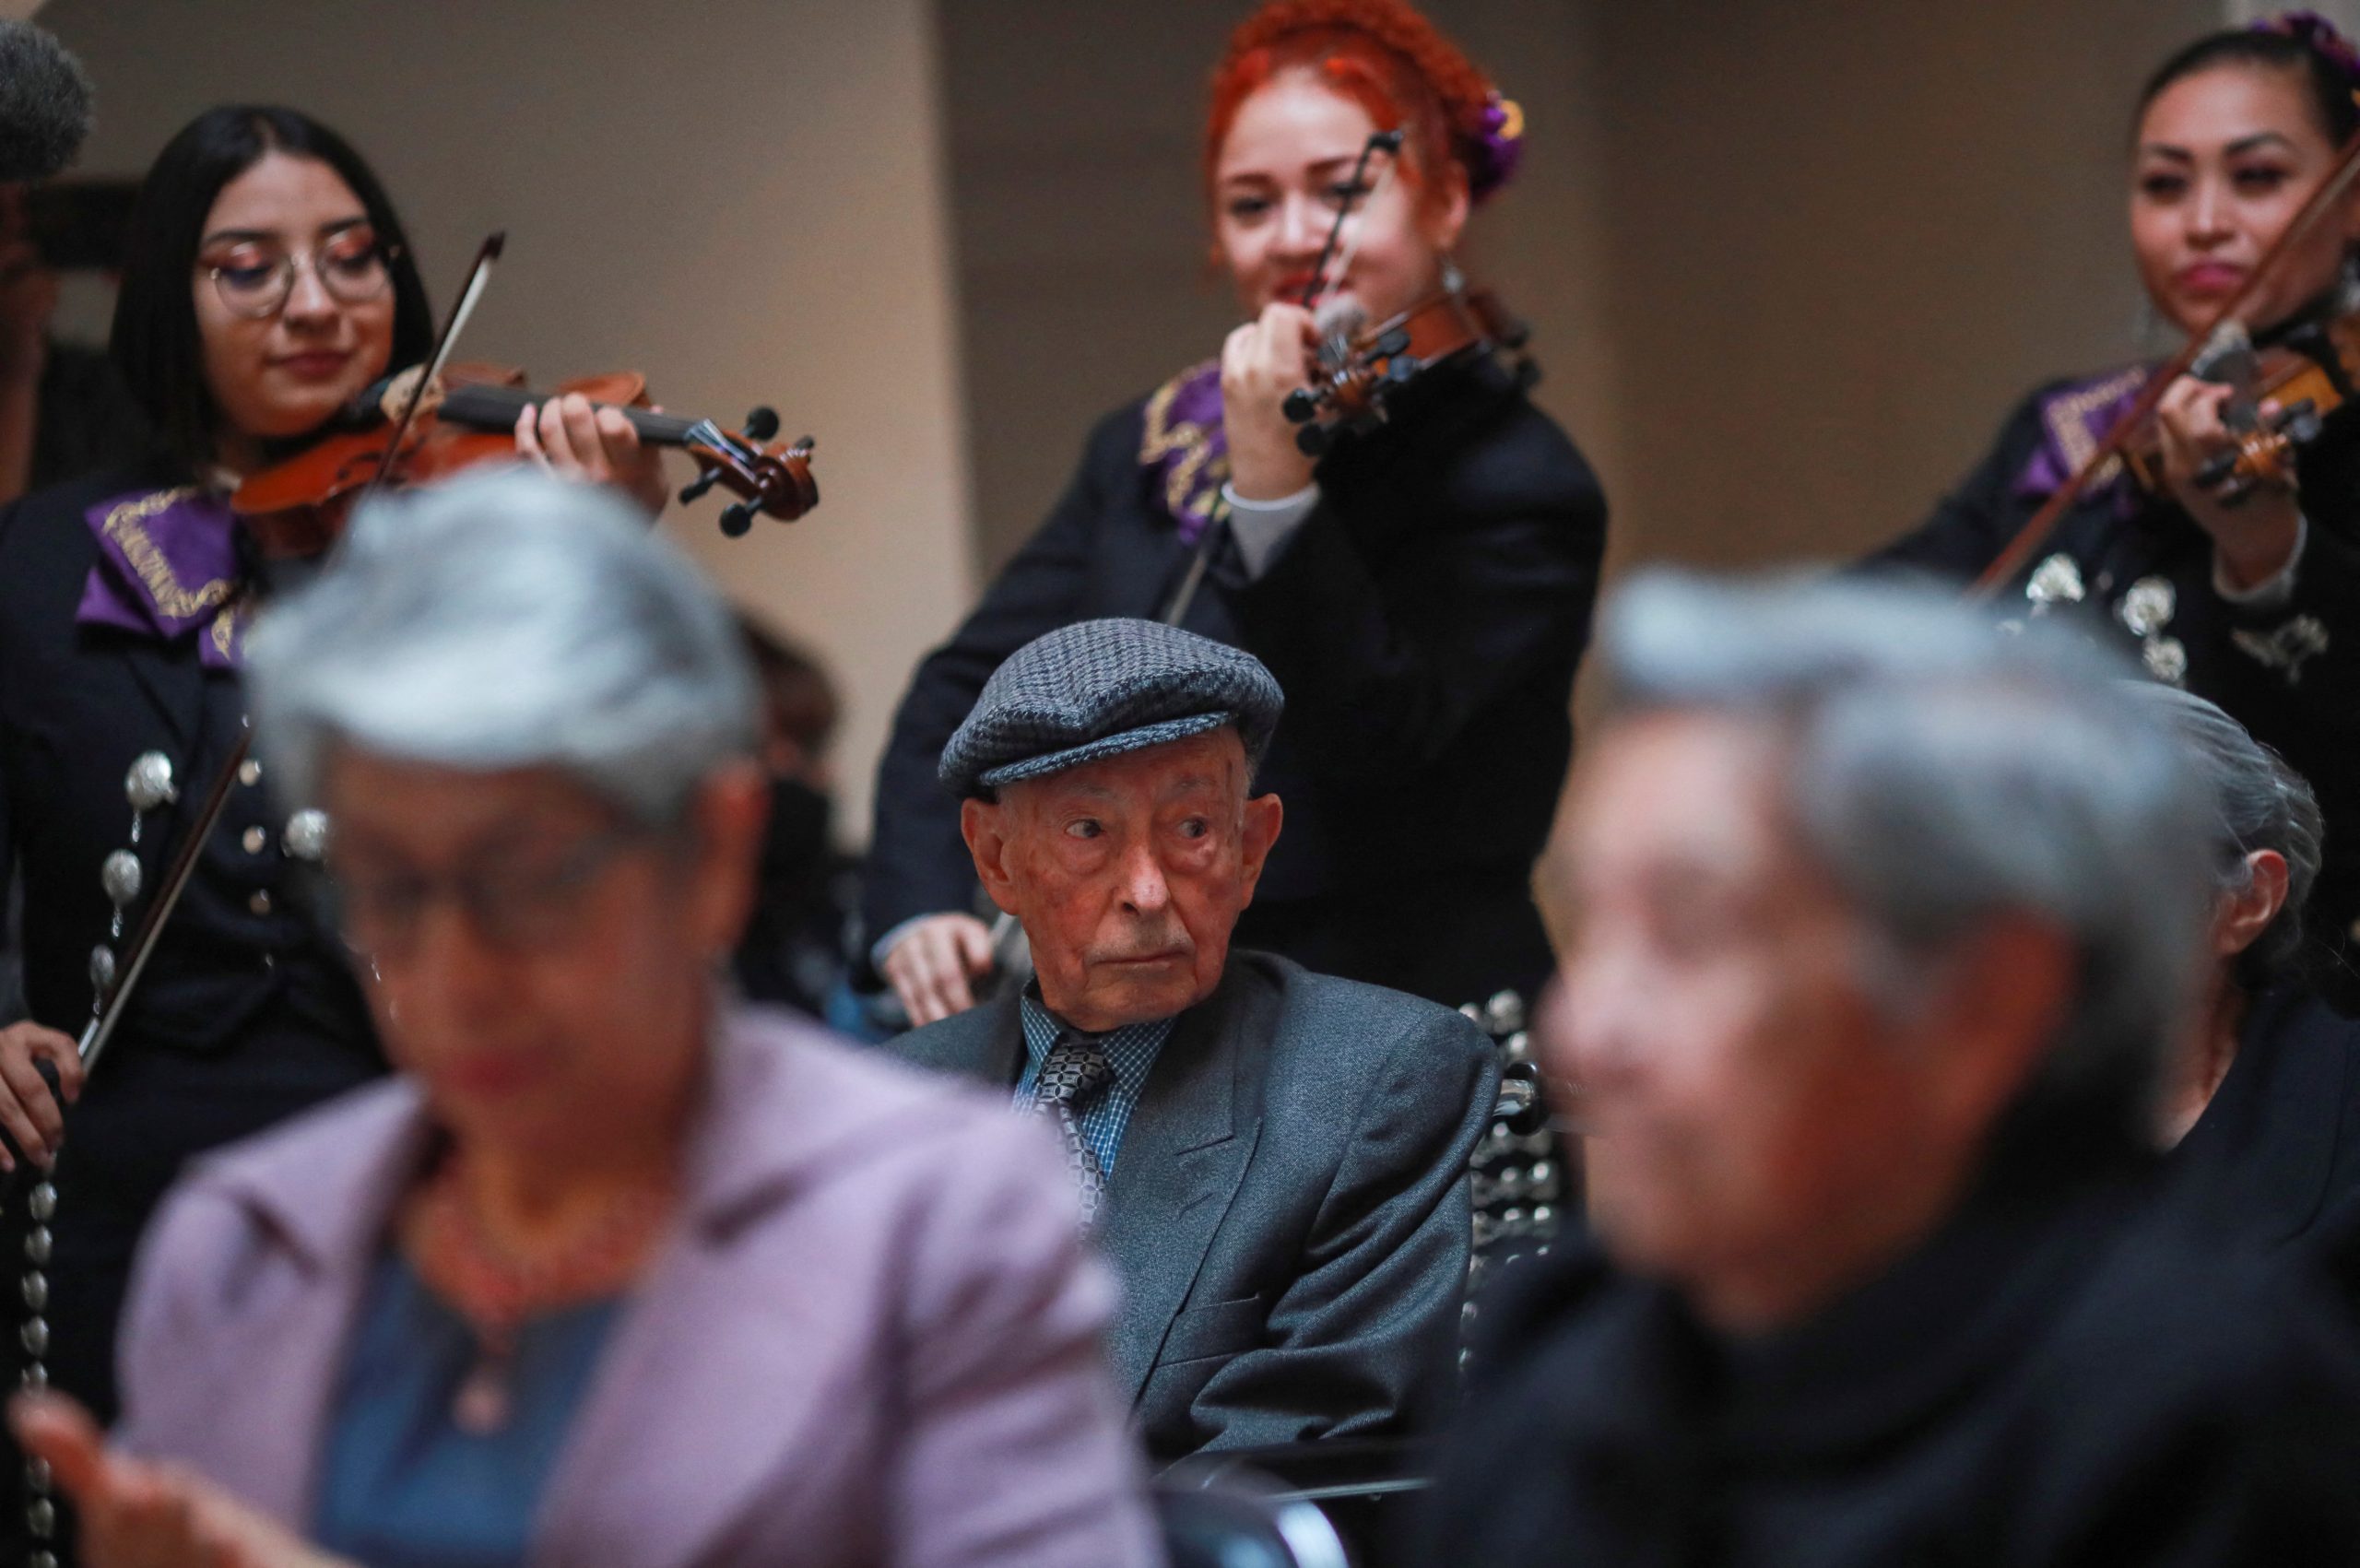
2133, 680, 2327, 989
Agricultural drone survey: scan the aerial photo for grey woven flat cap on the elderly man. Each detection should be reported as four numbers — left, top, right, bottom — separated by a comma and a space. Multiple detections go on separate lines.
937, 621, 1286, 796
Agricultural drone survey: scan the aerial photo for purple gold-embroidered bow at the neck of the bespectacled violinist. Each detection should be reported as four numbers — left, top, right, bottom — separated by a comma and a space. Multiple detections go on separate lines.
73, 484, 250, 671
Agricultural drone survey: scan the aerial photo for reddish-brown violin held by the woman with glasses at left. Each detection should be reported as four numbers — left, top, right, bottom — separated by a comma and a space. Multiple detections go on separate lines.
229, 366, 819, 555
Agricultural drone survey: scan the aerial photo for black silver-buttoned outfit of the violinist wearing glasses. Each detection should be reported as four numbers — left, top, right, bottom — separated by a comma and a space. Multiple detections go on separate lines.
0, 463, 384, 1414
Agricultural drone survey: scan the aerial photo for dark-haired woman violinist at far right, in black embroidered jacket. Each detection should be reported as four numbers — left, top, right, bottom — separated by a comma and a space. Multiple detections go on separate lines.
1874, 14, 2360, 999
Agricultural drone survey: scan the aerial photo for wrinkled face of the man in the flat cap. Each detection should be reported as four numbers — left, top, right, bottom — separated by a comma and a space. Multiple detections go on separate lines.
962, 727, 1281, 1032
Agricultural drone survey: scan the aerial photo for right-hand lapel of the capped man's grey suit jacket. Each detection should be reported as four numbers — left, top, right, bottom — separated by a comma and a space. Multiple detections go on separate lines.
1100, 959, 1268, 1400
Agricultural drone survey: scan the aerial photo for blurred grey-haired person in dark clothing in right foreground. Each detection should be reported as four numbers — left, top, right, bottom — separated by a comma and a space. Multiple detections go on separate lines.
1416, 579, 2360, 1568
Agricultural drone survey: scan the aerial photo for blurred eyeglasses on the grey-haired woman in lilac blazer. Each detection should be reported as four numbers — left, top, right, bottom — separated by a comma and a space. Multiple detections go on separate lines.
336, 824, 652, 961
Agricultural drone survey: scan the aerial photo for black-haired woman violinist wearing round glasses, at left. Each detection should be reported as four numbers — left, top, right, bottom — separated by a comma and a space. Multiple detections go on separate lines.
0, 106, 661, 1549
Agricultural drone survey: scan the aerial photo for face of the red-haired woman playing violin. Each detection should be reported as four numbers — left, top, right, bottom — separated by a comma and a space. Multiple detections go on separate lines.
1213, 68, 1468, 321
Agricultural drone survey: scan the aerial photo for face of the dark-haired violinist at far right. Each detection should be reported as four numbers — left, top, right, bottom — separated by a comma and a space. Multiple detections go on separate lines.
2131, 64, 2360, 333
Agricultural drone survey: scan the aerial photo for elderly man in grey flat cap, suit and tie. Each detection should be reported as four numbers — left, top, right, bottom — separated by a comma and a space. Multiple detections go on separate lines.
897, 621, 1499, 1459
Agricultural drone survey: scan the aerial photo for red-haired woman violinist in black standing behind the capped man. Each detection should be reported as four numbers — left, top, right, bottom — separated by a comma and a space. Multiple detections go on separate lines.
864, 0, 1605, 1025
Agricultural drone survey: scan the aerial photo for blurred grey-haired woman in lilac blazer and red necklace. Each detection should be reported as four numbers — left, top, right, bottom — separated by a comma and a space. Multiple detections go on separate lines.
18, 472, 1154, 1568
